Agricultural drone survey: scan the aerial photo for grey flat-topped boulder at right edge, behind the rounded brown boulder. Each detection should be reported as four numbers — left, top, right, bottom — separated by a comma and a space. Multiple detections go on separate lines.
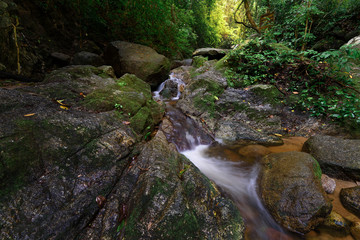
303, 135, 360, 180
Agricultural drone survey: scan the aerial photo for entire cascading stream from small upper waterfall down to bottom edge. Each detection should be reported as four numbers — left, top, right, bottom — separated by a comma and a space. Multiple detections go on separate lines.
154, 69, 293, 240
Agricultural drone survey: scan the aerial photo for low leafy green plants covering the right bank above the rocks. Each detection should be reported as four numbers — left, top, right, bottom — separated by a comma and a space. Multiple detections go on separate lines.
227, 39, 360, 125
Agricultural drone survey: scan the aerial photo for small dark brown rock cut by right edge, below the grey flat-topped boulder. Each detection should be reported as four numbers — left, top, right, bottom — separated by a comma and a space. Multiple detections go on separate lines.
340, 186, 360, 217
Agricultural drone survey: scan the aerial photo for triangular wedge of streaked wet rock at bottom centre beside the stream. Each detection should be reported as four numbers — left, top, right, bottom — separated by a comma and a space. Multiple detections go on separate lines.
76, 131, 244, 239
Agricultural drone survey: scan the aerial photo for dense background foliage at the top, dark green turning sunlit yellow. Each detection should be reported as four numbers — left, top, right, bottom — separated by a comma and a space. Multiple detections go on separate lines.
36, 0, 239, 58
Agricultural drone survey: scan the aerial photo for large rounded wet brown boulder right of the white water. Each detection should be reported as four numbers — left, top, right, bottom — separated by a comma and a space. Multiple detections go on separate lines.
259, 152, 332, 233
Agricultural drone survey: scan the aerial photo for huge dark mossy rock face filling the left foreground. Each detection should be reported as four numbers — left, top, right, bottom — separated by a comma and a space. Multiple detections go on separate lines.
0, 63, 244, 239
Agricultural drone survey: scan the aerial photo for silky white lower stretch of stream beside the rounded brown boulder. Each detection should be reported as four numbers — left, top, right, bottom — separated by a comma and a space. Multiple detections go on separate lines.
182, 145, 285, 240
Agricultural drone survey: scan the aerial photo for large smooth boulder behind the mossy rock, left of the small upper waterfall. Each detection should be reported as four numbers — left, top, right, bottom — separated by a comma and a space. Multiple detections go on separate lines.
104, 41, 170, 88
